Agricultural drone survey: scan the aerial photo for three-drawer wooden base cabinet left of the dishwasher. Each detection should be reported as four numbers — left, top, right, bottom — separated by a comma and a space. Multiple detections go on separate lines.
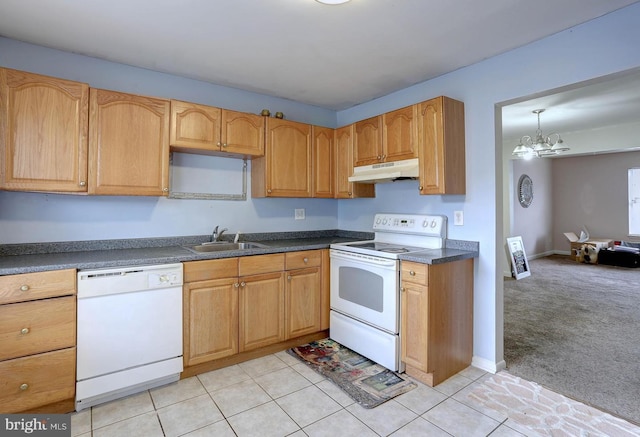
0, 269, 76, 413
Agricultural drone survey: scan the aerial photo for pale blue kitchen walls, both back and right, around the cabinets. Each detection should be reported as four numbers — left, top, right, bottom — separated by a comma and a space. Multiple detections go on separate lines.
0, 3, 640, 370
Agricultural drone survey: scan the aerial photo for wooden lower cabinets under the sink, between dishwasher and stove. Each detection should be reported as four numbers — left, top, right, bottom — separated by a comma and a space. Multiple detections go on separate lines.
183, 250, 329, 377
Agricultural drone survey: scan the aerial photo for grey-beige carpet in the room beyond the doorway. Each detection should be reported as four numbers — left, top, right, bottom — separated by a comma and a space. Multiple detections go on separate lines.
504, 255, 640, 424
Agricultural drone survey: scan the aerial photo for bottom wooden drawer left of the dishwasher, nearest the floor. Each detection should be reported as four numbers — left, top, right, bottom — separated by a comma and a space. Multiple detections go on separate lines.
0, 348, 76, 413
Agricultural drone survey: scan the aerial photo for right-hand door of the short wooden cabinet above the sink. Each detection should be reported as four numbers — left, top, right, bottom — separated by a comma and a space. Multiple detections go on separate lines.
221, 109, 265, 157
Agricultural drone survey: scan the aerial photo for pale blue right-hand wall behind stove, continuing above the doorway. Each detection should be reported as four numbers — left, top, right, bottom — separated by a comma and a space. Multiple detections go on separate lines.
338, 3, 640, 369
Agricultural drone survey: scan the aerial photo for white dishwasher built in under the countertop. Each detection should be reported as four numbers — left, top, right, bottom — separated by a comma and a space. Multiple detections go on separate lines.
76, 263, 183, 411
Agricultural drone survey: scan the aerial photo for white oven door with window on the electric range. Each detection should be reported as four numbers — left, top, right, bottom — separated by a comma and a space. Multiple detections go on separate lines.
330, 249, 399, 334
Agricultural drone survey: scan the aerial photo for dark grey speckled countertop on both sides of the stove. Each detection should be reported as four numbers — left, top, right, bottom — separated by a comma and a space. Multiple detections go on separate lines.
0, 230, 478, 276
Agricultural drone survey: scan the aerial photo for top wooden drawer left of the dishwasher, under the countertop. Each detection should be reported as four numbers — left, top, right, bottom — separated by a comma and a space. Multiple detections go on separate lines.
0, 269, 76, 304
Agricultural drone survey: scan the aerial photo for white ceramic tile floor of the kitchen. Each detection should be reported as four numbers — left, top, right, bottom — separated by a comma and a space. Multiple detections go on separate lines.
71, 351, 640, 437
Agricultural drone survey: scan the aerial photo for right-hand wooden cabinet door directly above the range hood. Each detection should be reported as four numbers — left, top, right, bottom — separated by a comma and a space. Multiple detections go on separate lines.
382, 105, 418, 162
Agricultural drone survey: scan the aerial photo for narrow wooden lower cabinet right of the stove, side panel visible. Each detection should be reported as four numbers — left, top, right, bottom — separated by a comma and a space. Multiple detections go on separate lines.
400, 259, 473, 386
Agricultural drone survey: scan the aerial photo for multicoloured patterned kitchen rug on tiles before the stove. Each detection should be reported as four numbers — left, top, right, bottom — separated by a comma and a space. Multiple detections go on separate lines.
287, 338, 417, 408
